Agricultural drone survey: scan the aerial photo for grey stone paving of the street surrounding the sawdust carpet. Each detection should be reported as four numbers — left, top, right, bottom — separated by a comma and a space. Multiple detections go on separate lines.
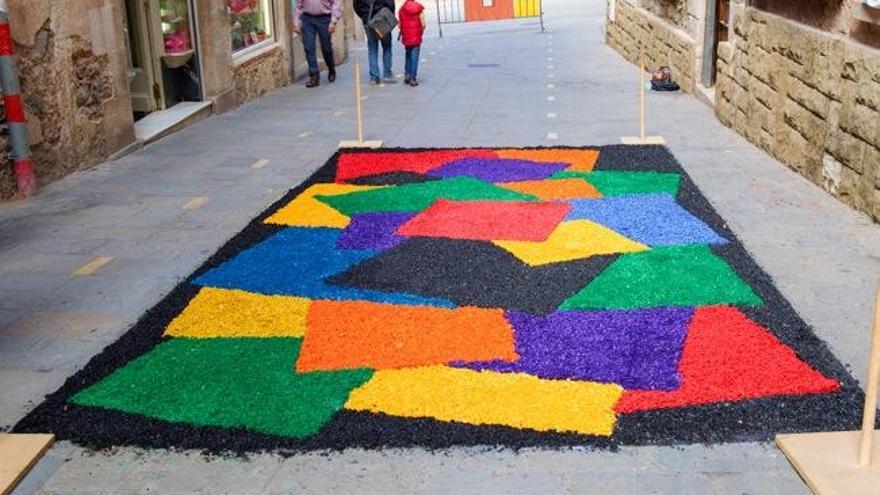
0, 0, 880, 495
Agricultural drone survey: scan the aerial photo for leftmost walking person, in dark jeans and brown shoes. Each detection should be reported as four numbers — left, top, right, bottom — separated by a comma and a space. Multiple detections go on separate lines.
293, 0, 342, 88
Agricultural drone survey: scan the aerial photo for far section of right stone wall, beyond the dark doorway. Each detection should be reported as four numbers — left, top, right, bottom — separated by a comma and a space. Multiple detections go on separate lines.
605, 0, 698, 92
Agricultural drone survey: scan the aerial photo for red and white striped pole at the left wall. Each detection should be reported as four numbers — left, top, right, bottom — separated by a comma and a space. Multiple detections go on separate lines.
0, 0, 37, 197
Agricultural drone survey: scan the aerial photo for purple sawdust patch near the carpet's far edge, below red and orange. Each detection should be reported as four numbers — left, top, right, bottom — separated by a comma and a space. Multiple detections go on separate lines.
429, 158, 569, 182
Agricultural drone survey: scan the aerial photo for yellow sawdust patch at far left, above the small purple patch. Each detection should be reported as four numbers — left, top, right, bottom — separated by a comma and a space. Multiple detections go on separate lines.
265, 184, 378, 229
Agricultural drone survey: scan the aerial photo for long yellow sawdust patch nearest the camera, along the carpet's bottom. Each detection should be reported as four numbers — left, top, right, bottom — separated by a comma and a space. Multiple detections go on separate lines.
345, 366, 623, 436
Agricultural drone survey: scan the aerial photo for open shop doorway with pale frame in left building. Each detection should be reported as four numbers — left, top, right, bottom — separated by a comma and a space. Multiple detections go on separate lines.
124, 0, 203, 121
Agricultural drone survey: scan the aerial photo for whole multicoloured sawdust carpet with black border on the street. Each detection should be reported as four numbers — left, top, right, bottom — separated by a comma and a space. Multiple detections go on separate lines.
16, 146, 860, 452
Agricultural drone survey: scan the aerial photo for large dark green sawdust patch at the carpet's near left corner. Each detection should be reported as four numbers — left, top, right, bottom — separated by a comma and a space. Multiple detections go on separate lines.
71, 338, 373, 438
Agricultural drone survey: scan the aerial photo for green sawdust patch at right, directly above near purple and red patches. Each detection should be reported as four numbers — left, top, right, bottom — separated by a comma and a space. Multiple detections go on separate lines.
560, 246, 761, 310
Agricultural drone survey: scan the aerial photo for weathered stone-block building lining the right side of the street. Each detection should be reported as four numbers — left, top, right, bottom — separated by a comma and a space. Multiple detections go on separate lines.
606, 0, 880, 220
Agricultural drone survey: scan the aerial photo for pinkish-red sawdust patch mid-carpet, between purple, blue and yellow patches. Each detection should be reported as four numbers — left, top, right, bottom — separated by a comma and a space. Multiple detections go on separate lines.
397, 199, 571, 242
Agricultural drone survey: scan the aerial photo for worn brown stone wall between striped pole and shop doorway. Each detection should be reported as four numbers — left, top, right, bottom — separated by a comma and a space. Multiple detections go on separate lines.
0, 0, 134, 199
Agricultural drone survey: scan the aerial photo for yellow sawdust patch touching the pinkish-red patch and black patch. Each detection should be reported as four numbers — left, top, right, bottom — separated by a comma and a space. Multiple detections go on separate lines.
493, 220, 648, 266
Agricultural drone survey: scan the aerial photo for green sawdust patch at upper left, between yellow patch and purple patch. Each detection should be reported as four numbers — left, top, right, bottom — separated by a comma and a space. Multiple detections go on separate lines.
315, 177, 538, 216
